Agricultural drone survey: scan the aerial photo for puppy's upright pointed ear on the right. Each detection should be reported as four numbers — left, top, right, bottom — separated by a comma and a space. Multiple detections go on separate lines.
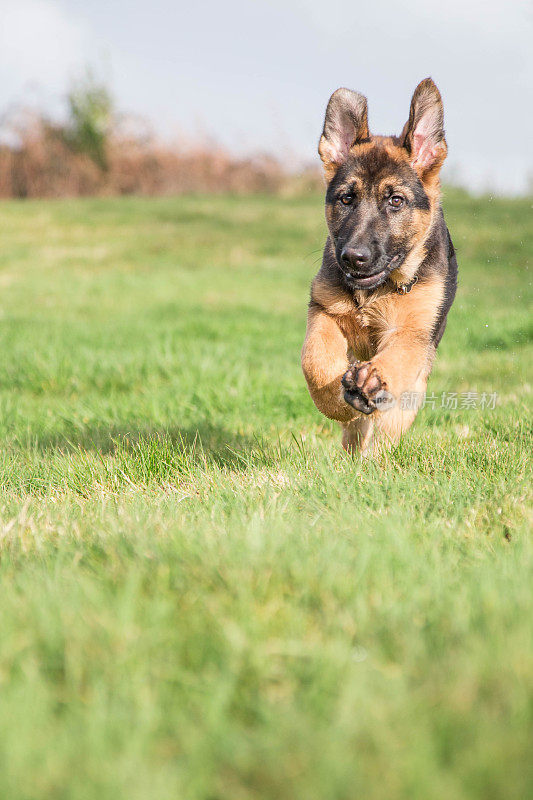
401, 78, 447, 176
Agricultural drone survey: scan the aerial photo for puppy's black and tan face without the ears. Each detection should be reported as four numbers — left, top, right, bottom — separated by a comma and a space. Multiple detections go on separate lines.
326, 144, 431, 289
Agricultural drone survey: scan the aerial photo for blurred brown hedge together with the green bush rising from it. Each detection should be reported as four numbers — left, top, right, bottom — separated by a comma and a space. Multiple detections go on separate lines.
0, 74, 321, 198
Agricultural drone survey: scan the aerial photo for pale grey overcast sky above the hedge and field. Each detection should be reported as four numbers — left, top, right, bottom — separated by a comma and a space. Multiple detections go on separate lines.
0, 0, 533, 192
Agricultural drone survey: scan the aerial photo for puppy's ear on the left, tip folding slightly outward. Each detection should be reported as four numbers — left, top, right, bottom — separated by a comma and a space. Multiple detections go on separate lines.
318, 89, 370, 179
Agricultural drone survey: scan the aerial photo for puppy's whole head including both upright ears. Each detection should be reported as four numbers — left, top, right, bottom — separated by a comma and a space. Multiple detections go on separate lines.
318, 78, 446, 289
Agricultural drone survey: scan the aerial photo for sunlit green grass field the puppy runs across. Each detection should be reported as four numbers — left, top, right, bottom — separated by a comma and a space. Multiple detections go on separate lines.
0, 191, 533, 800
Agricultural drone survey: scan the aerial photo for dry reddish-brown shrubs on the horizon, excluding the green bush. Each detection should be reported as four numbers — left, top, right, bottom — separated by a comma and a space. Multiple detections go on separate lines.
0, 114, 320, 198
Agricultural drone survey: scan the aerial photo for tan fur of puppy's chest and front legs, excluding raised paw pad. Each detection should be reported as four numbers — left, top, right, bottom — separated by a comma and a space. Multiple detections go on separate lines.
302, 279, 444, 451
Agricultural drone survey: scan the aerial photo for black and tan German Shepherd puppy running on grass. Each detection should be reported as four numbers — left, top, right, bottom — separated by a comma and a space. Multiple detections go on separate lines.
302, 78, 457, 453
